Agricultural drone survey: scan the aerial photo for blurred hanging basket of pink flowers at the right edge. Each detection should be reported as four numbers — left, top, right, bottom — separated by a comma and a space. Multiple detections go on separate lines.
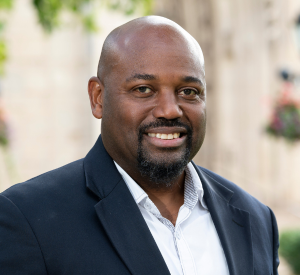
266, 82, 300, 141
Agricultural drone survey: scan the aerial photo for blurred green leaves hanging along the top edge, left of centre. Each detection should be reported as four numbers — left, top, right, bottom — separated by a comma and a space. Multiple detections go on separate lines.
31, 0, 152, 32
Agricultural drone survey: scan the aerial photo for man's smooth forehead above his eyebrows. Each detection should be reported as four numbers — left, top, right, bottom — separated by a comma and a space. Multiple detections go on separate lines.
104, 26, 204, 82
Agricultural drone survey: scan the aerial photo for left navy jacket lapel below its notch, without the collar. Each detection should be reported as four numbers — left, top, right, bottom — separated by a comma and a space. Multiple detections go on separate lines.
95, 180, 170, 275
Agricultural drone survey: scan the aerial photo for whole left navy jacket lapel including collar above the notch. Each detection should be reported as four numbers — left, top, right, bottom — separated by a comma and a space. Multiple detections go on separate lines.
84, 136, 170, 275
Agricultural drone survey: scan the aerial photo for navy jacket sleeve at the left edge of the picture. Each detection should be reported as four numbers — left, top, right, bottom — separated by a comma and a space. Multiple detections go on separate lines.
0, 194, 47, 275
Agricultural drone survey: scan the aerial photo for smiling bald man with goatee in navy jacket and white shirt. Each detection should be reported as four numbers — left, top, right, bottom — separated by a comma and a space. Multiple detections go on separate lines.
0, 16, 279, 275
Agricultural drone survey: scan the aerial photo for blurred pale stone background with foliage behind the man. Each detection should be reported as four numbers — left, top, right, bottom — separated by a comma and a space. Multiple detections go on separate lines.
0, 0, 300, 275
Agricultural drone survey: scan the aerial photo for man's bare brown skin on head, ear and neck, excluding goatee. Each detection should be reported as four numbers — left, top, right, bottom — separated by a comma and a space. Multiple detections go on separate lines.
88, 16, 206, 225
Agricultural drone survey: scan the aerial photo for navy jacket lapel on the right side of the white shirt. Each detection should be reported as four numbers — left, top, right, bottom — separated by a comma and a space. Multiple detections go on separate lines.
193, 163, 254, 275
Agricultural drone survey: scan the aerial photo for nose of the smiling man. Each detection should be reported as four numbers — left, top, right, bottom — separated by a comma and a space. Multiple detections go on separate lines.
152, 90, 183, 120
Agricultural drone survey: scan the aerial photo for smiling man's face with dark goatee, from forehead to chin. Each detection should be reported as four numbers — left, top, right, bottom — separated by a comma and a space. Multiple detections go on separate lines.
101, 28, 206, 187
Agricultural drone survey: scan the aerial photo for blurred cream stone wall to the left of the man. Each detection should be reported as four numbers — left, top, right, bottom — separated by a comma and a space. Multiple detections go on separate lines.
0, 0, 133, 191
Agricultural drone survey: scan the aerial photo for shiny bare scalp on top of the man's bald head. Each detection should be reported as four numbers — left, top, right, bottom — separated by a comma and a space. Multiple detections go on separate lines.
97, 16, 204, 83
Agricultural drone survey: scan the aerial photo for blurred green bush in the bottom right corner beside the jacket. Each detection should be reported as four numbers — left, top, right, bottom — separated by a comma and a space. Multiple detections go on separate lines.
279, 229, 300, 274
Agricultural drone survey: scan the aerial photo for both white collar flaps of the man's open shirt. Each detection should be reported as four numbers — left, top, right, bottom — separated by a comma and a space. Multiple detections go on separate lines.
114, 161, 207, 209
